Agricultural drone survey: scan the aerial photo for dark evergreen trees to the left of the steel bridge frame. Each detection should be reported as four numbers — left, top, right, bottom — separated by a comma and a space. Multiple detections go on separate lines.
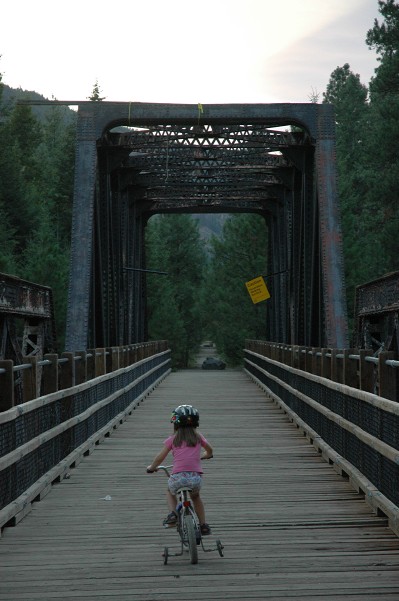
0, 86, 75, 350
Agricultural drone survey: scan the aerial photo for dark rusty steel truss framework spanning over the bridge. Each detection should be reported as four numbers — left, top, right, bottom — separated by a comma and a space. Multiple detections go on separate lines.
61, 102, 347, 350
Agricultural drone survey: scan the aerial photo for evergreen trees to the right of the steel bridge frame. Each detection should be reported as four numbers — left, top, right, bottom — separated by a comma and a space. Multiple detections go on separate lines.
323, 0, 399, 330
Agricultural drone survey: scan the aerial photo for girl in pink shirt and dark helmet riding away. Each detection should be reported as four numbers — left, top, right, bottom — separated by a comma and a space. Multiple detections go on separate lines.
147, 405, 213, 536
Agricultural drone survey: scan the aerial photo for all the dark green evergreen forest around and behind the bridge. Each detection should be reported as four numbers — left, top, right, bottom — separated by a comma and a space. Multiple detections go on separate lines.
0, 0, 399, 367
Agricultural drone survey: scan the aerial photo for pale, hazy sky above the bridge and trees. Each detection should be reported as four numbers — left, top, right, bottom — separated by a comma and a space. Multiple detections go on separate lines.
0, 0, 382, 104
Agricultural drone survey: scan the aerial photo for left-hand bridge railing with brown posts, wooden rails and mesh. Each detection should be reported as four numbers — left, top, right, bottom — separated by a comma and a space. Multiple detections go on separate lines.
0, 341, 171, 528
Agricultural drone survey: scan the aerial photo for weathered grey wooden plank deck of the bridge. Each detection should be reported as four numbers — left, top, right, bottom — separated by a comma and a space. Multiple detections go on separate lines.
0, 369, 399, 601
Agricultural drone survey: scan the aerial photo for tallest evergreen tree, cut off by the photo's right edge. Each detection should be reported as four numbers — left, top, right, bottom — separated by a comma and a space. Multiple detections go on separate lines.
364, 0, 399, 277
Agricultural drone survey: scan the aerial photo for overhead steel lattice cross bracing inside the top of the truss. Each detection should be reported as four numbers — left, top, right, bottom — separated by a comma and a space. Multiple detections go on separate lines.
107, 124, 305, 210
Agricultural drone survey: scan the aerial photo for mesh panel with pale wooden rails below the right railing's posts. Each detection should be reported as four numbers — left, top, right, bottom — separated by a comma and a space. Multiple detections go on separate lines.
245, 349, 399, 523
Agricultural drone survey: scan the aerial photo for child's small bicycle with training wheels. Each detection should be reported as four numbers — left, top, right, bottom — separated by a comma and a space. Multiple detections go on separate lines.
148, 465, 224, 565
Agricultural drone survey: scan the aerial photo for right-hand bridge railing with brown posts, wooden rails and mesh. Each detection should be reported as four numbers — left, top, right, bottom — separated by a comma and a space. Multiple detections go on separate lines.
244, 340, 399, 535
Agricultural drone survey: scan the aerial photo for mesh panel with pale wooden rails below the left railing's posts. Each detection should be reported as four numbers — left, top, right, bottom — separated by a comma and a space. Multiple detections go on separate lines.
0, 344, 170, 526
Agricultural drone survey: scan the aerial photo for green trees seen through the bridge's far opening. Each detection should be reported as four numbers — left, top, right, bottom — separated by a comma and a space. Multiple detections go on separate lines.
146, 215, 267, 367
